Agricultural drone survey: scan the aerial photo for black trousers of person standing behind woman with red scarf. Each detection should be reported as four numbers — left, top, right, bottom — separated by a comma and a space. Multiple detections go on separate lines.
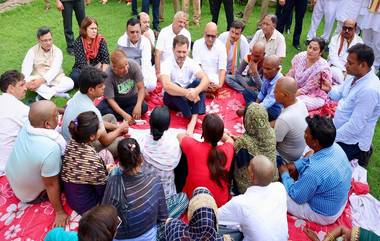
62, 0, 86, 49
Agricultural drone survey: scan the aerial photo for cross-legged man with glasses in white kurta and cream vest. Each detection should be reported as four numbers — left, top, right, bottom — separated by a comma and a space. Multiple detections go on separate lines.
21, 27, 74, 100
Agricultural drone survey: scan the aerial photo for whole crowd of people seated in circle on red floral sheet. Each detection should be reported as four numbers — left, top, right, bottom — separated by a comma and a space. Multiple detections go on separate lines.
0, 7, 380, 241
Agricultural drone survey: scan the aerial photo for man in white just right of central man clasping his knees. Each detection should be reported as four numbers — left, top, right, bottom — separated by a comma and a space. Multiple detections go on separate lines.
193, 22, 227, 95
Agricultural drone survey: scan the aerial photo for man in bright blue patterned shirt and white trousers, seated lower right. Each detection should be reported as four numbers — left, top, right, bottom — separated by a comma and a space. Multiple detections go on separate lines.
279, 116, 352, 225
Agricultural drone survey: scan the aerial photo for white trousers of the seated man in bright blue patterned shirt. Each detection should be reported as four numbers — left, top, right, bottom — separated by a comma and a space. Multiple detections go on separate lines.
287, 195, 347, 225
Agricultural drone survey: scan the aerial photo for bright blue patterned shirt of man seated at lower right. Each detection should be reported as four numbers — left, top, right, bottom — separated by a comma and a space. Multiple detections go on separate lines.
281, 143, 352, 216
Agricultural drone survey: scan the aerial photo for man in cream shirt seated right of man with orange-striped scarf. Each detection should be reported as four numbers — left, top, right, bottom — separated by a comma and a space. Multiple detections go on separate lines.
249, 14, 286, 60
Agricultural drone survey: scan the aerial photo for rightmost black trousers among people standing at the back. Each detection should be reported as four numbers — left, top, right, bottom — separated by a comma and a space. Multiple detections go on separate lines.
276, 0, 308, 45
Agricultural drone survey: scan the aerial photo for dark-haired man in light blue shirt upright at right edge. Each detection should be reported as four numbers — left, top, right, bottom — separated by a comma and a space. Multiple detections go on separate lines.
322, 44, 380, 167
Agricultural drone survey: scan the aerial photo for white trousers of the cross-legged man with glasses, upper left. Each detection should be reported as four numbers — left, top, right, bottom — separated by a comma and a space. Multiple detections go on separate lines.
30, 74, 74, 100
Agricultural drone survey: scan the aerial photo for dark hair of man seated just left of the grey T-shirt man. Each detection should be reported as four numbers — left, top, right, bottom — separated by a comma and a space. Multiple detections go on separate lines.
79, 66, 107, 94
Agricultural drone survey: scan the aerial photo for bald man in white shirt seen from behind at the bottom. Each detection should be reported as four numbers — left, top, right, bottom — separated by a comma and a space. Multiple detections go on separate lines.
218, 155, 288, 241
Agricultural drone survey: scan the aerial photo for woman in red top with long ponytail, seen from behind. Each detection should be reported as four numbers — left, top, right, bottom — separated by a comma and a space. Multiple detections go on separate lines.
178, 114, 234, 207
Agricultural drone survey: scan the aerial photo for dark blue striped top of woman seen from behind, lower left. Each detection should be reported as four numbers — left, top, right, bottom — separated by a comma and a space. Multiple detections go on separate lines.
102, 173, 168, 239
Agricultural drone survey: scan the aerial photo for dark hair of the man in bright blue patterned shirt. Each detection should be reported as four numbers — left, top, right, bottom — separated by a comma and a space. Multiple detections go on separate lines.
306, 115, 336, 148
